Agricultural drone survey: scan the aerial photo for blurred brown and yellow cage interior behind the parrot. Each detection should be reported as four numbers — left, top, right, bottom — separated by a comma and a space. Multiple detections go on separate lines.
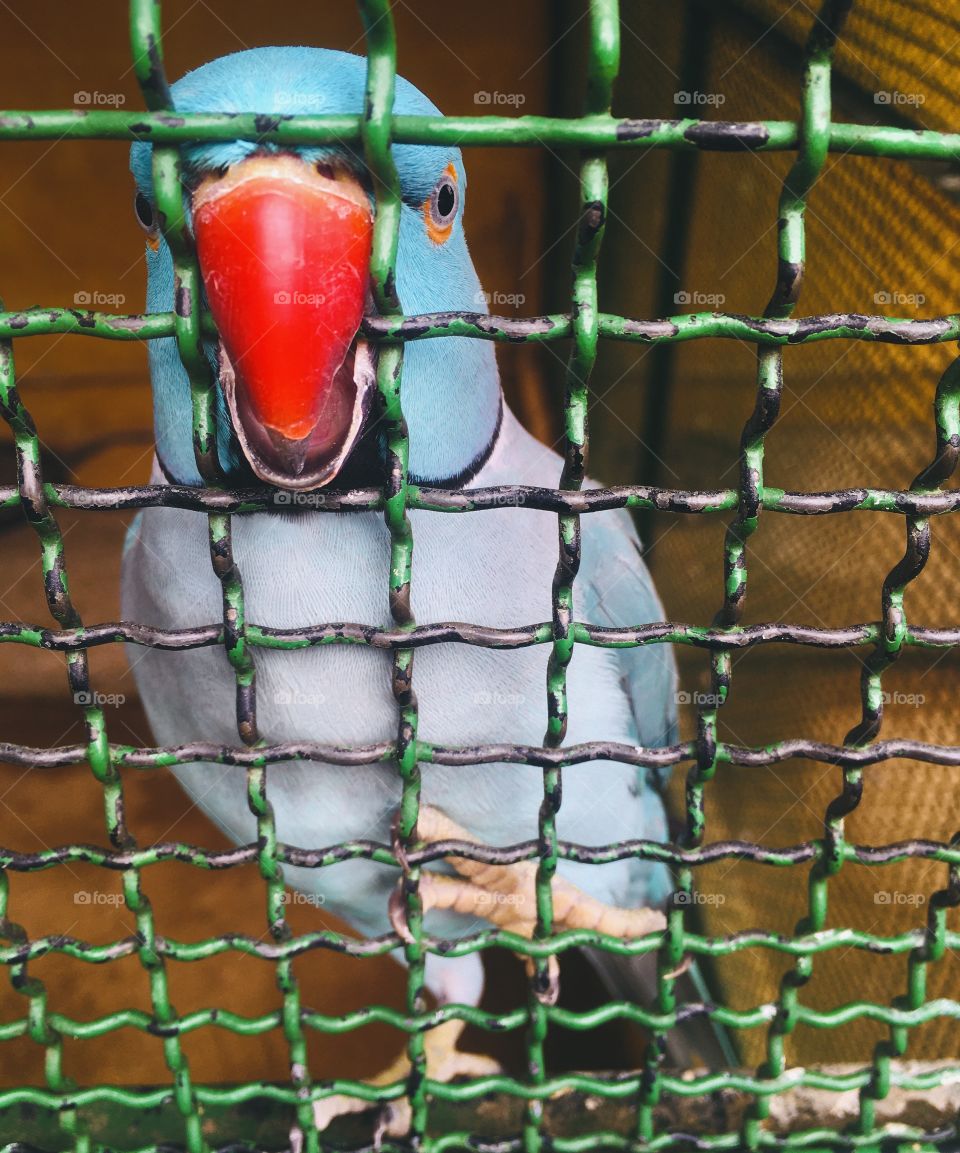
0, 0, 960, 1106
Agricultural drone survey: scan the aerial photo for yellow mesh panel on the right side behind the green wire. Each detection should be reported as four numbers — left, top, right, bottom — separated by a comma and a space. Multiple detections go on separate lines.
626, 9, 960, 1063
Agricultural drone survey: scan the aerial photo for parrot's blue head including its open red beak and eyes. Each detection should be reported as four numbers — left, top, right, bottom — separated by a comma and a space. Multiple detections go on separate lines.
130, 47, 501, 489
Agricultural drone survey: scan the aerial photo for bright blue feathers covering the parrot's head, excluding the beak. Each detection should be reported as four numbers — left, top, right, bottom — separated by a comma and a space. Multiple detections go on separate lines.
130, 47, 500, 484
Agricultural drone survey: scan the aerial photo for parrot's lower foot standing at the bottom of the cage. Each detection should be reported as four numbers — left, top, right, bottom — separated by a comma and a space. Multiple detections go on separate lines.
313, 1020, 502, 1148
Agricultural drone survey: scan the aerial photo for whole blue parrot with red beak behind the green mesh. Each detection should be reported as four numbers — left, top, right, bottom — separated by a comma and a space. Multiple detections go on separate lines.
122, 47, 721, 1125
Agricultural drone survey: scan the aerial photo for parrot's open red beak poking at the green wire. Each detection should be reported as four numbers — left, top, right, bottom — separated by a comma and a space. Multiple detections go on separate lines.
192, 155, 376, 489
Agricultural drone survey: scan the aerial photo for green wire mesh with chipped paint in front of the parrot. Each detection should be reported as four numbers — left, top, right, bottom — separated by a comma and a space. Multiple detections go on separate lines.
0, 0, 960, 1153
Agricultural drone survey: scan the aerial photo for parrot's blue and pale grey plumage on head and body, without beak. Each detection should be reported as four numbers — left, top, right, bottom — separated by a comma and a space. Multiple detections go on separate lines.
123, 47, 719, 1125
